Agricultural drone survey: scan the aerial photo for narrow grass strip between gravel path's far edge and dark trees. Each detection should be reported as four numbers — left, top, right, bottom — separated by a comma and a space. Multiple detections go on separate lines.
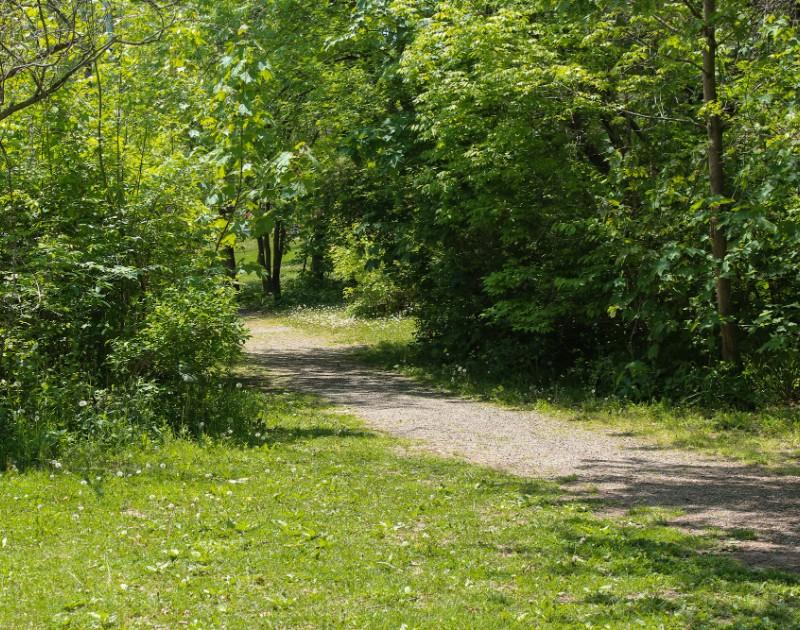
276, 308, 800, 474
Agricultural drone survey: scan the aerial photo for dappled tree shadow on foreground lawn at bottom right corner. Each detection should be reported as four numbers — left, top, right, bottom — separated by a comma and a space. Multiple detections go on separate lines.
479, 481, 800, 628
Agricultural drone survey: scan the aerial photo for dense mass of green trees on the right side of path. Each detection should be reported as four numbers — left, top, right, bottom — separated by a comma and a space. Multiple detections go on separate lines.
296, 0, 800, 404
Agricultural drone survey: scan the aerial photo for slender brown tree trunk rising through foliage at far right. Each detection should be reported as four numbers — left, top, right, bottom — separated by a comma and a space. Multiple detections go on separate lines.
703, 0, 738, 362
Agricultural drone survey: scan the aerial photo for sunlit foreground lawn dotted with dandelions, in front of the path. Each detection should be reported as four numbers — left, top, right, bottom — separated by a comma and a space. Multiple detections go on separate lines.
0, 394, 800, 629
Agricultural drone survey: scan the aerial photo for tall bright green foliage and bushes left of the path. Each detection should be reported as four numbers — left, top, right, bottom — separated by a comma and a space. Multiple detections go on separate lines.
0, 2, 243, 467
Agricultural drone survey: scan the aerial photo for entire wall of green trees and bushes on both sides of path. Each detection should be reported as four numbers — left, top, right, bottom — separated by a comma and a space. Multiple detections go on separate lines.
0, 0, 800, 462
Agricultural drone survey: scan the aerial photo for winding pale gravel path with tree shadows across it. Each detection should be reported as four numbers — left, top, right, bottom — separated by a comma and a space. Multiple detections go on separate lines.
247, 318, 800, 571
